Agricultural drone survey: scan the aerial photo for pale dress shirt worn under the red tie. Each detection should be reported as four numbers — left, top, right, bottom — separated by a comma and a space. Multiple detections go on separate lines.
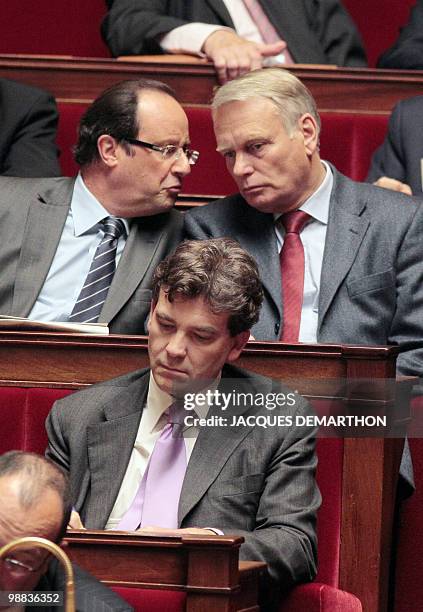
274, 161, 333, 342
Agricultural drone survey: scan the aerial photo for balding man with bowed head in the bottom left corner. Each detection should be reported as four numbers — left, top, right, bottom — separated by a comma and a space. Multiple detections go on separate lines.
0, 451, 133, 612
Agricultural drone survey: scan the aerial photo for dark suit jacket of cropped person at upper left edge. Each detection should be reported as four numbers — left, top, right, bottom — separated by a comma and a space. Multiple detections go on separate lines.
0, 79, 61, 177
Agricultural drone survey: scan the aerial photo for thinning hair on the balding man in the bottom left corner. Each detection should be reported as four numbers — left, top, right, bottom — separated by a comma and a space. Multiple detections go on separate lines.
0, 451, 72, 542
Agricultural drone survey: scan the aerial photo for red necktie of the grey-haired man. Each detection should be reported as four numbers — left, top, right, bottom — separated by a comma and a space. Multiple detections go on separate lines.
279, 210, 310, 342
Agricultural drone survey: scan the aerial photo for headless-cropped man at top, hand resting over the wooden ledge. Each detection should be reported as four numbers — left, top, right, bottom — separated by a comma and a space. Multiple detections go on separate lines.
102, 0, 366, 82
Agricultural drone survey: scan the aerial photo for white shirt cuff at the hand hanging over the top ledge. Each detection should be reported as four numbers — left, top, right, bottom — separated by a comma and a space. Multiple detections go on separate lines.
159, 22, 234, 57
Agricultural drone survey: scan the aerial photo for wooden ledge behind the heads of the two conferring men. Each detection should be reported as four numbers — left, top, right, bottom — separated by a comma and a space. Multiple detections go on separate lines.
0, 55, 423, 114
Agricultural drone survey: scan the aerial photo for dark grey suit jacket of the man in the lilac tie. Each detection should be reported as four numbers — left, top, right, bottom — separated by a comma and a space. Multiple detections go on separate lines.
46, 366, 320, 587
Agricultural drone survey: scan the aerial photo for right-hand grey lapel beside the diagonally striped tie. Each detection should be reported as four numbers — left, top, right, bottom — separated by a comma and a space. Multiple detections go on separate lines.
99, 215, 169, 321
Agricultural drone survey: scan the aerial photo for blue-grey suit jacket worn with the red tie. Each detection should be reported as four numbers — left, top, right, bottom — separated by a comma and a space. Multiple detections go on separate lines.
185, 167, 423, 376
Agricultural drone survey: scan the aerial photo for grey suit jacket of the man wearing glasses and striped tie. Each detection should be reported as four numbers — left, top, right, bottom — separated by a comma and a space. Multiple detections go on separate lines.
0, 177, 182, 334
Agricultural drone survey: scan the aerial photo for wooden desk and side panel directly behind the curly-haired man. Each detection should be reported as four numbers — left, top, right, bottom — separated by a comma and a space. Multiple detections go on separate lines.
0, 332, 409, 612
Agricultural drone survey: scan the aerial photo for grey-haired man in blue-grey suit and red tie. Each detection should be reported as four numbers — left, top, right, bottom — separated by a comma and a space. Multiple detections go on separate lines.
186, 68, 423, 384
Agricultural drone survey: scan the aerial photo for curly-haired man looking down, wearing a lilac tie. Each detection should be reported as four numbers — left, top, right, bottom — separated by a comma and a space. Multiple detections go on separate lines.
46, 239, 320, 604
